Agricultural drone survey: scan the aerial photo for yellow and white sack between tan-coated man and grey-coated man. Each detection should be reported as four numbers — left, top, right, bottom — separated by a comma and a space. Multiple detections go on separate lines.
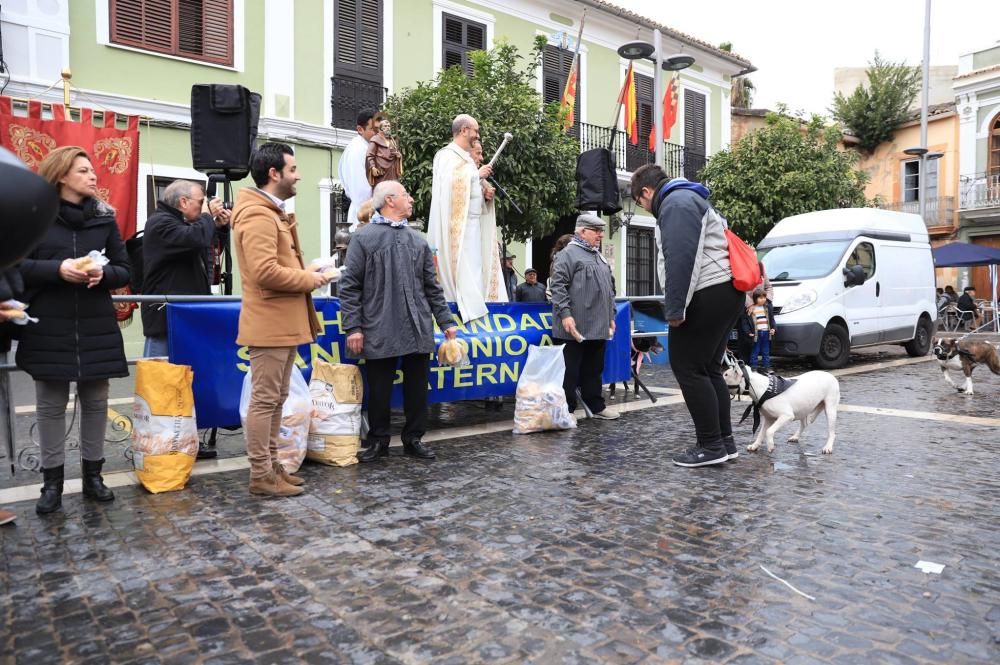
306, 360, 364, 466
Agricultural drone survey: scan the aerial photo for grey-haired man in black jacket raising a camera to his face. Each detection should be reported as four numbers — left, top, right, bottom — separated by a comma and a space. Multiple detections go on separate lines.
142, 180, 231, 358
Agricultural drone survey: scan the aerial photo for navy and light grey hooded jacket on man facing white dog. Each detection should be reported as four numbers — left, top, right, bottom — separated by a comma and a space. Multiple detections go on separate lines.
654, 178, 733, 321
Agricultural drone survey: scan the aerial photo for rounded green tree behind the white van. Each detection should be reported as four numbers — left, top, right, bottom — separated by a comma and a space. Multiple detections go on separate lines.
701, 106, 867, 243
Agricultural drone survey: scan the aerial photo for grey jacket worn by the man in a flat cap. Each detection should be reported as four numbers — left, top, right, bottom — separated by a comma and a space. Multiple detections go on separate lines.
549, 243, 615, 340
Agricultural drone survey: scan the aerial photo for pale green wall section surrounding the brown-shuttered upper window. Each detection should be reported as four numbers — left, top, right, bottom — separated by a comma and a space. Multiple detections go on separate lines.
69, 0, 264, 104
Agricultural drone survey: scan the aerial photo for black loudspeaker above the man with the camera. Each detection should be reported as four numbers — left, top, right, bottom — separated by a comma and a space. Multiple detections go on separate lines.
191, 83, 260, 180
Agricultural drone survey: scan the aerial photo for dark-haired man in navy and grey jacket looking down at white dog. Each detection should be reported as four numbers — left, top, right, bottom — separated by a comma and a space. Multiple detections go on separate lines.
632, 164, 744, 467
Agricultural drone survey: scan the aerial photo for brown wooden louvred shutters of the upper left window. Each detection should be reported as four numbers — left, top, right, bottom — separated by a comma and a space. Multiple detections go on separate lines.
110, 0, 233, 65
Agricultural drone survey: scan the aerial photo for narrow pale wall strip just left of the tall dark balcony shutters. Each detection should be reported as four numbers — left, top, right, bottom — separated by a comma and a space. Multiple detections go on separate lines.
295, 0, 333, 125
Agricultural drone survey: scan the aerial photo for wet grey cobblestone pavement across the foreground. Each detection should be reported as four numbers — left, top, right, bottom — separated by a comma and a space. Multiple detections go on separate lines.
0, 356, 1000, 665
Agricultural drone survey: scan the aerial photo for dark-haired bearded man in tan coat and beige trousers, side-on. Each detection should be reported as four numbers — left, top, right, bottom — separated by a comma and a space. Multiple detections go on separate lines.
232, 143, 329, 496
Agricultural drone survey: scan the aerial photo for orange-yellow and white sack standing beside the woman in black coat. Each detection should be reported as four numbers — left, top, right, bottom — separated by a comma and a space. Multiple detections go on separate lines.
132, 360, 198, 494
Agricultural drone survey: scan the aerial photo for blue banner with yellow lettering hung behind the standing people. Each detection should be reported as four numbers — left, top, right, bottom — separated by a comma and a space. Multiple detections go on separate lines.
167, 298, 631, 428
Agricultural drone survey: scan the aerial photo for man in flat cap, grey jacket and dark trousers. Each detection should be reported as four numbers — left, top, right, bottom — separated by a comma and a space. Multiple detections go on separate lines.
550, 213, 618, 420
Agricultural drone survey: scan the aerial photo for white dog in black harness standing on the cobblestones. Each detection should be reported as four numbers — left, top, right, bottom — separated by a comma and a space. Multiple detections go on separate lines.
743, 367, 840, 455
